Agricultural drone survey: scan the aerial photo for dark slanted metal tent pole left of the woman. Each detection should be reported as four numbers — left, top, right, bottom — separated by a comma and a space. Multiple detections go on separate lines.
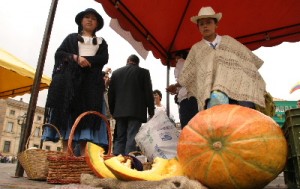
15, 0, 58, 177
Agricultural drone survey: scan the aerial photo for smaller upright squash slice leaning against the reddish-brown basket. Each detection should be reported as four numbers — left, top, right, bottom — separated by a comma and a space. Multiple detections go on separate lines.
85, 142, 116, 178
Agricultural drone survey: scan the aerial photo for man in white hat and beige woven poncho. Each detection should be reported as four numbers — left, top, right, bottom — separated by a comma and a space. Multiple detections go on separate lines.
178, 7, 265, 110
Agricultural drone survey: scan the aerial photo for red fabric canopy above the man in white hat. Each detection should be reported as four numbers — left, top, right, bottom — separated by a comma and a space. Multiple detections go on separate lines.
96, 0, 300, 65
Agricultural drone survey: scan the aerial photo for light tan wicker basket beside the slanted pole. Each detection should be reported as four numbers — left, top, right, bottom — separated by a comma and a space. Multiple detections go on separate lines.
17, 123, 63, 180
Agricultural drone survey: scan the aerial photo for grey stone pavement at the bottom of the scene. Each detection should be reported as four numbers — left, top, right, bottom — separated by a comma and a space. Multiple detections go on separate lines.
0, 163, 287, 189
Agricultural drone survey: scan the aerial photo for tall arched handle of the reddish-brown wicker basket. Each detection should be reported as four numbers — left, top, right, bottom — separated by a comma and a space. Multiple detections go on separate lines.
67, 111, 112, 156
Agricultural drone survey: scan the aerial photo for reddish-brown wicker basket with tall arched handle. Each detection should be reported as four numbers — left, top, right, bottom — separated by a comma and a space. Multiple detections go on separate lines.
47, 111, 111, 184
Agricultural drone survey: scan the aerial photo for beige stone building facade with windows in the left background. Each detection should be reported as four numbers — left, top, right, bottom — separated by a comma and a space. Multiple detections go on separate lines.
0, 98, 62, 157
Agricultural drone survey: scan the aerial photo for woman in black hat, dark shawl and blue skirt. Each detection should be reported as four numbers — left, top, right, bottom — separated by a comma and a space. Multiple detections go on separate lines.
43, 8, 108, 155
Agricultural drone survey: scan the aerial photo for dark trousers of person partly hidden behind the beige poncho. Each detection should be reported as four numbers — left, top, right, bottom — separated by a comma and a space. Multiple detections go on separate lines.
179, 97, 198, 129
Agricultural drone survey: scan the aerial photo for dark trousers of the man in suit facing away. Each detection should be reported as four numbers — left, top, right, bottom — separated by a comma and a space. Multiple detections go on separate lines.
113, 117, 142, 155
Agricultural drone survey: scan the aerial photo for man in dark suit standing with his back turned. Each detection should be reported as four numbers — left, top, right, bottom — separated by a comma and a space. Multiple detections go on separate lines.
108, 55, 155, 155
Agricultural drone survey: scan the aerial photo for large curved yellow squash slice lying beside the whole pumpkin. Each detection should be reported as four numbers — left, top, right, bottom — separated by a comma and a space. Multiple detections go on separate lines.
104, 155, 183, 181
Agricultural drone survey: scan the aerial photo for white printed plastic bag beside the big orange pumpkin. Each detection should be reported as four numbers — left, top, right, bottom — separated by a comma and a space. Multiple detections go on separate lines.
135, 111, 180, 161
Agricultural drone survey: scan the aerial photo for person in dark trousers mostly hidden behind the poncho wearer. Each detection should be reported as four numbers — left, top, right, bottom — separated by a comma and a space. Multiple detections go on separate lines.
166, 50, 198, 129
